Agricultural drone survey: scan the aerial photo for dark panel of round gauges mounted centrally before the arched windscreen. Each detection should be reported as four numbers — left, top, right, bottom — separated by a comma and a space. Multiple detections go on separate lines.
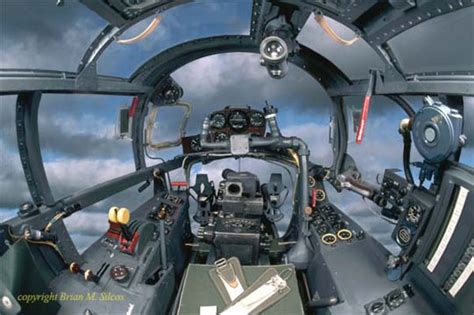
210, 107, 266, 142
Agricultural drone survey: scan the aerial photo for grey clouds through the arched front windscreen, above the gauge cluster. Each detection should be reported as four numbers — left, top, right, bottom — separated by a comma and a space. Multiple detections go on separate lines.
173, 53, 331, 139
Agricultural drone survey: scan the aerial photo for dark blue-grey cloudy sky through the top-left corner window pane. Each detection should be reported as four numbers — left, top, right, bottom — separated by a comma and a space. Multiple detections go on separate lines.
0, 0, 105, 71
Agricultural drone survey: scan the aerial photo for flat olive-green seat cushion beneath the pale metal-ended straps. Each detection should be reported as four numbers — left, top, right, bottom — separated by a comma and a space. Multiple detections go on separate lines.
178, 264, 304, 315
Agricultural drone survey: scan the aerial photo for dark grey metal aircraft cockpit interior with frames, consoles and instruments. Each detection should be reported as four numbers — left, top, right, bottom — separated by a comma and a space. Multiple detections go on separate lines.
0, 0, 474, 315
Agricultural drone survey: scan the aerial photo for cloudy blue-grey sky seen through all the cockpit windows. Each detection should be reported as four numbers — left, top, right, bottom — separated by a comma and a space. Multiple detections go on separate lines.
0, 0, 473, 251
